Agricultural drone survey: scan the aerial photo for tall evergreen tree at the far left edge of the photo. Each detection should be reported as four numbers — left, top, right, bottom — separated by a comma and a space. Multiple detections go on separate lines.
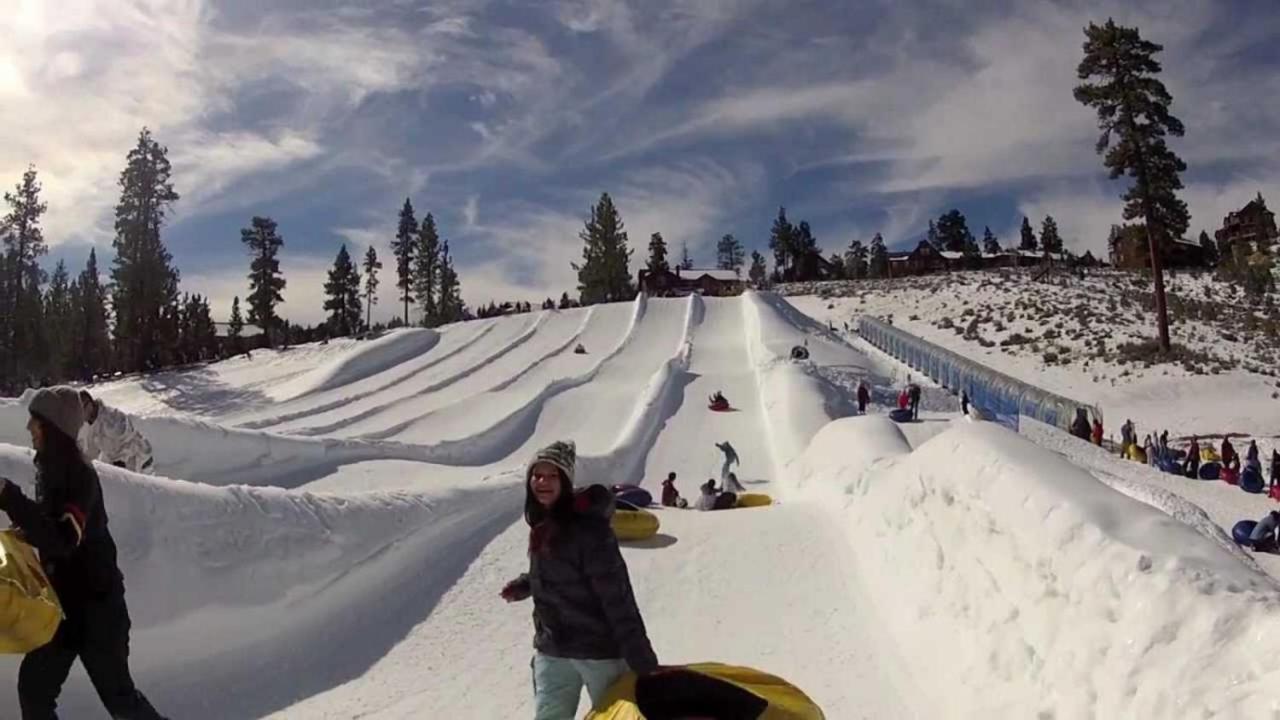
0, 167, 49, 377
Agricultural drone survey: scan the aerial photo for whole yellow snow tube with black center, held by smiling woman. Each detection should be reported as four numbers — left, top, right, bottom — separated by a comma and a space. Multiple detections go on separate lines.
586, 662, 826, 720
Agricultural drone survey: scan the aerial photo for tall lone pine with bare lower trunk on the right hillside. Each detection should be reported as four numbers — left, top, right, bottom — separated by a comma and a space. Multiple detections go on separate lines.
1074, 19, 1190, 352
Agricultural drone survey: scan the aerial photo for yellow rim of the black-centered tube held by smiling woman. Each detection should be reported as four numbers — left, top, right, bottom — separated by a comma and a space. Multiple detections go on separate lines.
585, 662, 826, 720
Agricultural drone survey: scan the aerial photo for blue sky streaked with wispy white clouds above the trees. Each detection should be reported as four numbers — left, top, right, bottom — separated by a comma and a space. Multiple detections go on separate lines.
0, 0, 1280, 323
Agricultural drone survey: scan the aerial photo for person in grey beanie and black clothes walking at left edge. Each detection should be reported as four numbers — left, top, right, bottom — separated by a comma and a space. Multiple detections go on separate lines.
0, 386, 161, 720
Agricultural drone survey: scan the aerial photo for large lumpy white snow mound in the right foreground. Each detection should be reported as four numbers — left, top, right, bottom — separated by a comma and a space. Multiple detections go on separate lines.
797, 419, 1280, 717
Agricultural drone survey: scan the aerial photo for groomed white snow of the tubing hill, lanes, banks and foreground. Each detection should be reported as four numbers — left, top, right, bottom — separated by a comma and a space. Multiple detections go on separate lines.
0, 292, 1280, 720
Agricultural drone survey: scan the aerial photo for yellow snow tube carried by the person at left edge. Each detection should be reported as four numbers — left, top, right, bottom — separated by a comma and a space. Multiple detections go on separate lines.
0, 530, 63, 655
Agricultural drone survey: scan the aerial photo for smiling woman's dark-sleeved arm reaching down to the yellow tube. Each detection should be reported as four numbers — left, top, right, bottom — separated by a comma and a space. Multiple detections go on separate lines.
584, 521, 658, 674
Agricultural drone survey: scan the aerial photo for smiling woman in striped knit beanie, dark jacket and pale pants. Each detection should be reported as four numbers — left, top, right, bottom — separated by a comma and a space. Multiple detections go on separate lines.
502, 442, 658, 720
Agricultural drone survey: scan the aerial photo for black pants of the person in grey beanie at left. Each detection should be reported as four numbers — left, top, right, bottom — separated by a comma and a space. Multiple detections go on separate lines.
18, 597, 163, 720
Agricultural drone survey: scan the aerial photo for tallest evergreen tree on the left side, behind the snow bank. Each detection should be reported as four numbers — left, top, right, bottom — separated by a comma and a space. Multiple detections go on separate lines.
111, 128, 178, 370
